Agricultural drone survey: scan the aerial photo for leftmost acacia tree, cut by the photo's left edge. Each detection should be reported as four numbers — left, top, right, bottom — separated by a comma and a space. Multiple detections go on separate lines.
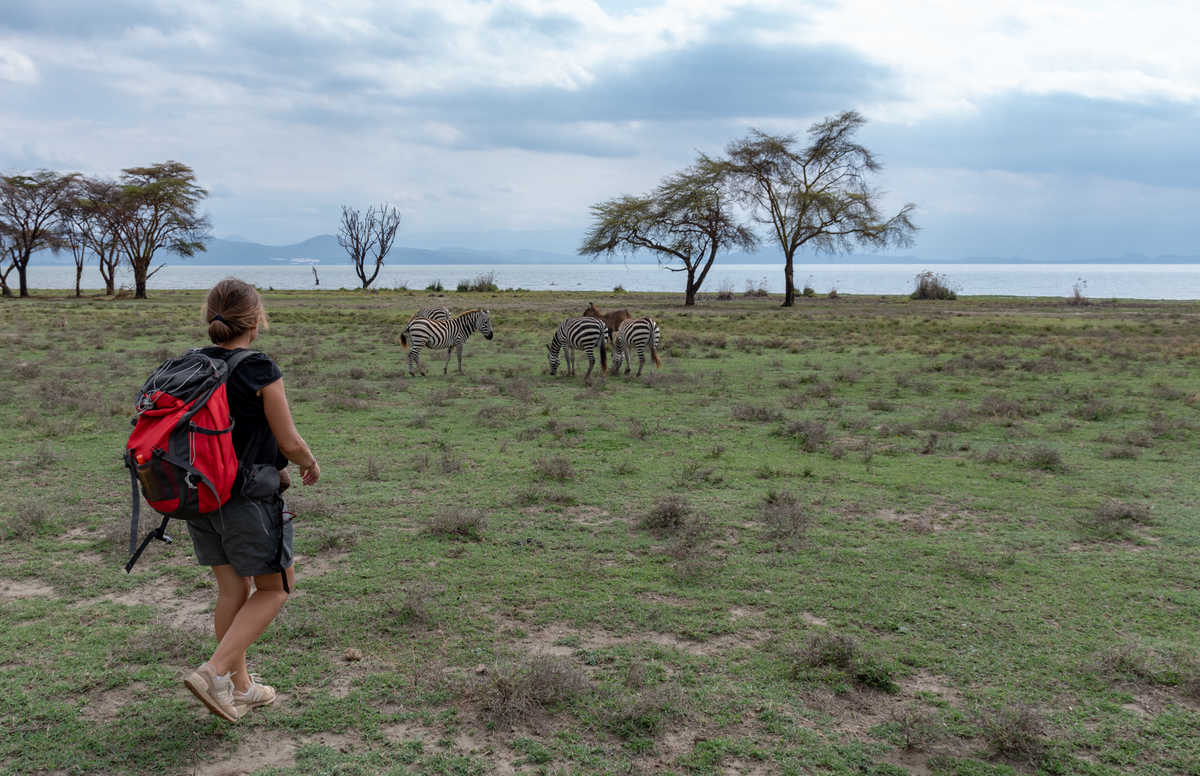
0, 170, 76, 296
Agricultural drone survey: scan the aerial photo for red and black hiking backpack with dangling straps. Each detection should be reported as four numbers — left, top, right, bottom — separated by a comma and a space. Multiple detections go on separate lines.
125, 349, 254, 571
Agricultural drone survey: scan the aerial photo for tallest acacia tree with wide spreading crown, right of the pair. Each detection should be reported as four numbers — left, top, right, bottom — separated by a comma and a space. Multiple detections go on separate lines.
724, 110, 917, 307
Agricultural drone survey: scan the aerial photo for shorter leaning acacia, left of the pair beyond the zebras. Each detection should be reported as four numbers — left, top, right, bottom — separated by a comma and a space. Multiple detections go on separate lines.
580, 158, 756, 306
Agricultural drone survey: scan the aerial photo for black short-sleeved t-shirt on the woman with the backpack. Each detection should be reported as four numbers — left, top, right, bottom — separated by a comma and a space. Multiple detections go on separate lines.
200, 345, 288, 472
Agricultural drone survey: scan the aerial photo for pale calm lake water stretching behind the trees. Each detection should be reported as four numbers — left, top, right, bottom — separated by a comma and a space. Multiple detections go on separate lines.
23, 260, 1200, 299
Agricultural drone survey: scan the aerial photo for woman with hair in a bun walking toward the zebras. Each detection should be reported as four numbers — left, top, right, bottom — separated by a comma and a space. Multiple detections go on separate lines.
184, 277, 320, 722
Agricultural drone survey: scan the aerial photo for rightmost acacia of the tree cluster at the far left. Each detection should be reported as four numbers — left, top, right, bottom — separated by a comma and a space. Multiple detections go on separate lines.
116, 161, 210, 299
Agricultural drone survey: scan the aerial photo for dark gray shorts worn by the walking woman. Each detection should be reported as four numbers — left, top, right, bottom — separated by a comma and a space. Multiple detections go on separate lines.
187, 493, 293, 577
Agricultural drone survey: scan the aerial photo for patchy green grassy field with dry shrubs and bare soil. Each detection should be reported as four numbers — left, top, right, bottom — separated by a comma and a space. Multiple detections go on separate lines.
0, 291, 1200, 776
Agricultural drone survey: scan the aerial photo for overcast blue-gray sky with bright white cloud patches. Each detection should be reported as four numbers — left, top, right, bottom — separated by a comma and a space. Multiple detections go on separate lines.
0, 0, 1200, 259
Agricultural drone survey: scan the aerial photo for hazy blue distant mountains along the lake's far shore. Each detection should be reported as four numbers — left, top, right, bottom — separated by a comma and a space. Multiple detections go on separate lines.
25, 234, 1200, 266
